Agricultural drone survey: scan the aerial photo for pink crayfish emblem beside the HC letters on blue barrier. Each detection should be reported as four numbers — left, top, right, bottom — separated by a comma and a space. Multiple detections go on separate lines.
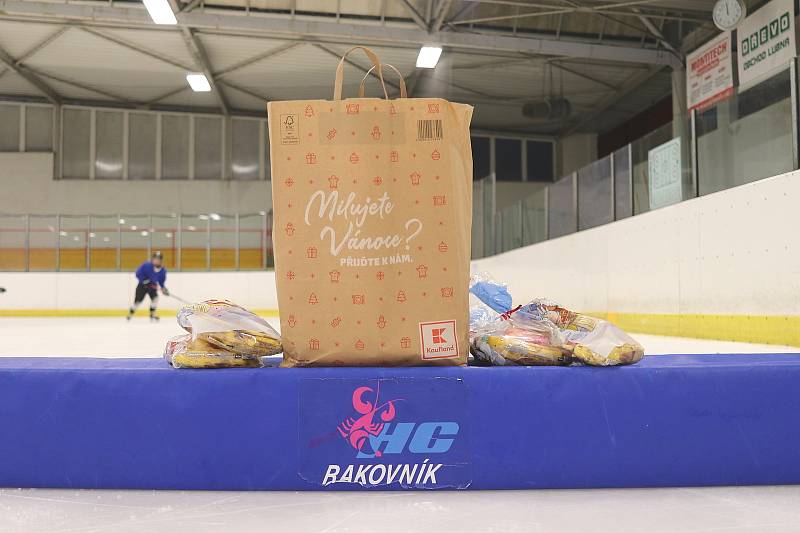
336, 386, 400, 457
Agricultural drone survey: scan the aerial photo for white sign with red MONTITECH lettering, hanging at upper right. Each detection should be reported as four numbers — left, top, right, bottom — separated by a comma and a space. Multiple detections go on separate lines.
686, 32, 733, 111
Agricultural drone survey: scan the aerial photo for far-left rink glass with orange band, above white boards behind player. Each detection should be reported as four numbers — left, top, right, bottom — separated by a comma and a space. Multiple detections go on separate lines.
0, 211, 274, 272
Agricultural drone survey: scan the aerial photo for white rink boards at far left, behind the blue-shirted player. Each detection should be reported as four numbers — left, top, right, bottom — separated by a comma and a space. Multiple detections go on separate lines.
0, 271, 278, 311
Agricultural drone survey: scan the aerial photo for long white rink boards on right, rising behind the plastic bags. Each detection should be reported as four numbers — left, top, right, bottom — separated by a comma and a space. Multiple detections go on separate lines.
473, 168, 800, 315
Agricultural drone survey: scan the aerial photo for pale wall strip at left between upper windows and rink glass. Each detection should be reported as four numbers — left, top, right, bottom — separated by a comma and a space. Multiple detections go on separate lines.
0, 153, 272, 215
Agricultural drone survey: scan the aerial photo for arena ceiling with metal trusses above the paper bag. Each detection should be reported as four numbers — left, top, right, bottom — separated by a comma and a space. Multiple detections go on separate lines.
0, 0, 715, 135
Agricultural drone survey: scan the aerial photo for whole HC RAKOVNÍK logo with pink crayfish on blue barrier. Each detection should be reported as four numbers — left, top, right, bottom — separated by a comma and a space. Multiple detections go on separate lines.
322, 385, 460, 486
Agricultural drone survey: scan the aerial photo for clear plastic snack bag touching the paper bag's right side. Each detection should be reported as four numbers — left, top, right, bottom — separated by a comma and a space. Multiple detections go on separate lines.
470, 315, 572, 366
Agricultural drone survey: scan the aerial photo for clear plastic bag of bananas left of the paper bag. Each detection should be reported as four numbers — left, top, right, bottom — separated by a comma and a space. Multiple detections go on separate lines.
164, 300, 283, 368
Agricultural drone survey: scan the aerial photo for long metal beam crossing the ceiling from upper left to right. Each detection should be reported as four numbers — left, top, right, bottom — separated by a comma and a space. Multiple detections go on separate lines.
0, 0, 680, 68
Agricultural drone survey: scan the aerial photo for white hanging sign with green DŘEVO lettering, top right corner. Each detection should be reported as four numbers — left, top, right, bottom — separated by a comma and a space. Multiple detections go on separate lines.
737, 0, 797, 86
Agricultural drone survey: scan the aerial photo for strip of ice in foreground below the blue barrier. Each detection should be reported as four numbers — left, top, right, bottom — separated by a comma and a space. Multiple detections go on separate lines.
0, 487, 800, 533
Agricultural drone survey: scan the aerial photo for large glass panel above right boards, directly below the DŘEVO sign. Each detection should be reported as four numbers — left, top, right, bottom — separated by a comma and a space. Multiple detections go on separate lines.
695, 69, 794, 195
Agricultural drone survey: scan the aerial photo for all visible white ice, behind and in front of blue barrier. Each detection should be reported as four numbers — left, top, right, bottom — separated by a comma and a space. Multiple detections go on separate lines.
0, 317, 800, 532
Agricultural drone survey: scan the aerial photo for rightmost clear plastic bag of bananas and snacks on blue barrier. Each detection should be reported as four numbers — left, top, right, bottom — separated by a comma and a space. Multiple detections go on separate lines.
514, 299, 644, 366
